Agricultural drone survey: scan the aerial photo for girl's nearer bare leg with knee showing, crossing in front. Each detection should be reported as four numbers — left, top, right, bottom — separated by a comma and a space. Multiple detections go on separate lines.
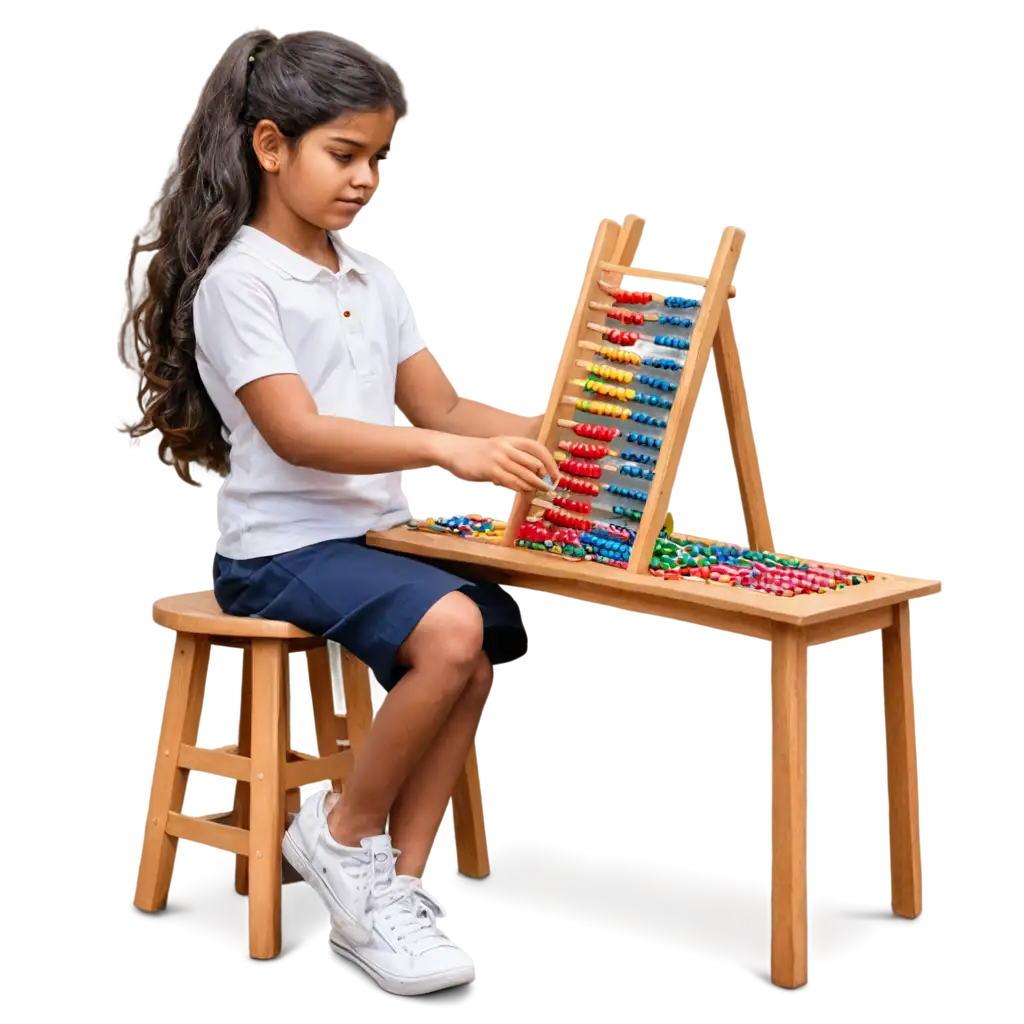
328, 591, 483, 849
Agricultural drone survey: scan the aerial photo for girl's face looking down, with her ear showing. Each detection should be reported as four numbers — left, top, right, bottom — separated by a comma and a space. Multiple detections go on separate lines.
253, 110, 395, 231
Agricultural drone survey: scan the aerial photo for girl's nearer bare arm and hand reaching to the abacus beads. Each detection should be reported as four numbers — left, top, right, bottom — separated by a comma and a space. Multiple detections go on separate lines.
238, 374, 556, 490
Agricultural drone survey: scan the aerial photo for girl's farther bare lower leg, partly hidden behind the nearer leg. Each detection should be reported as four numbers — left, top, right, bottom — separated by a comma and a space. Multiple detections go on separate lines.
390, 648, 493, 876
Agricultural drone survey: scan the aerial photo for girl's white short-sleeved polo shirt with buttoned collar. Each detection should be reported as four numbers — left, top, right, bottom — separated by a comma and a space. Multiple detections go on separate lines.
193, 226, 426, 558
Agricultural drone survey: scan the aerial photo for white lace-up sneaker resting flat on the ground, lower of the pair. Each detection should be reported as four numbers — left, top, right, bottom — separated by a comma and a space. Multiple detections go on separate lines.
328, 848, 478, 995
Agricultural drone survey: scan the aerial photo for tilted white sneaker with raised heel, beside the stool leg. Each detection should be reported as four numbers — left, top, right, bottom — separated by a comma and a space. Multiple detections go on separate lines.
282, 790, 378, 942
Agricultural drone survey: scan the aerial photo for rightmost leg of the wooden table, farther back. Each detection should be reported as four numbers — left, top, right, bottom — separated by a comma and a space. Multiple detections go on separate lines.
882, 604, 923, 920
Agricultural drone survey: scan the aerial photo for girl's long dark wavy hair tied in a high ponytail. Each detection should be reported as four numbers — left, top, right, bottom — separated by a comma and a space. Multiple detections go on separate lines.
129, 32, 406, 478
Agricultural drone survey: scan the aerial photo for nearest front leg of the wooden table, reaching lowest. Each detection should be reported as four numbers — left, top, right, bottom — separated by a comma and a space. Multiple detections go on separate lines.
768, 626, 808, 988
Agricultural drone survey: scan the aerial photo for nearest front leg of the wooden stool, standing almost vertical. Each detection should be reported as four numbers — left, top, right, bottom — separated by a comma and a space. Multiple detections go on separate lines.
243, 640, 286, 959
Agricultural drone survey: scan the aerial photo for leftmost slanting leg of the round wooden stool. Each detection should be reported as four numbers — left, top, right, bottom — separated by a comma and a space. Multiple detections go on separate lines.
133, 633, 207, 913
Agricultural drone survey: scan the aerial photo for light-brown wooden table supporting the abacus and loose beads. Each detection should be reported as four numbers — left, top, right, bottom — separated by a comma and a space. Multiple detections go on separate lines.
369, 526, 942, 989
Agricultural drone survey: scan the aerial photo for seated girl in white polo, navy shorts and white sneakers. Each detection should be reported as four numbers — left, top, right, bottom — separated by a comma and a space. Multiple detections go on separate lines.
133, 33, 557, 994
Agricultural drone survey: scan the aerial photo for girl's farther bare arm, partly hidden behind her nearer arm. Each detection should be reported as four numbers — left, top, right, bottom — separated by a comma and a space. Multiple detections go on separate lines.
395, 348, 541, 437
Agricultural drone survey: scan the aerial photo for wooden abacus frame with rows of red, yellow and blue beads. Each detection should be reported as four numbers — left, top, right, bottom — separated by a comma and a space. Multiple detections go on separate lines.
502, 216, 767, 573
